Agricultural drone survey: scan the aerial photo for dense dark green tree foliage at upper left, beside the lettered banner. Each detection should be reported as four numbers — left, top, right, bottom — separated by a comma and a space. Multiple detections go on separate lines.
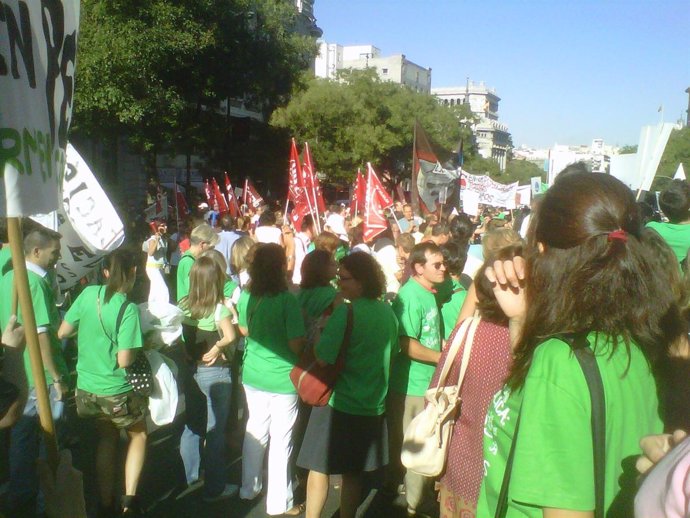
73, 0, 316, 160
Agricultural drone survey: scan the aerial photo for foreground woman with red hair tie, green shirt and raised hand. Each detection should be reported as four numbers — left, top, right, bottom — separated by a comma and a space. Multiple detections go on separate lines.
477, 173, 686, 517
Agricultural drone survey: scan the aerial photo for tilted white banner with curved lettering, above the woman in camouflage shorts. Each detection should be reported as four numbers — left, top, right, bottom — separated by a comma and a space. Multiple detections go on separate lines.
57, 144, 125, 291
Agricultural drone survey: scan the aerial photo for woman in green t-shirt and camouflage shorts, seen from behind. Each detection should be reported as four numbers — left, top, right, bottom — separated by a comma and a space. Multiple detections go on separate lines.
58, 249, 148, 517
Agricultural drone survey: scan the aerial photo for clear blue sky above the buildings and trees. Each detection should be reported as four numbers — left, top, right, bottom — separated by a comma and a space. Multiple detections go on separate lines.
314, 0, 690, 147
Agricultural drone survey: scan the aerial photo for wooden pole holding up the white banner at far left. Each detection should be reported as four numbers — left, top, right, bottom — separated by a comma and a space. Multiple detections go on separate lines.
7, 218, 58, 471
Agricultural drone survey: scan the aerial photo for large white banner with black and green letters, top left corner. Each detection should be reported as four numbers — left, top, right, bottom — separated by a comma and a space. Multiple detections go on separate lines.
0, 0, 79, 217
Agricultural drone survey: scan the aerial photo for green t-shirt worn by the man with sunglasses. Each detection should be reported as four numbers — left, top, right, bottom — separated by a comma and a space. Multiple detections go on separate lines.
390, 279, 441, 396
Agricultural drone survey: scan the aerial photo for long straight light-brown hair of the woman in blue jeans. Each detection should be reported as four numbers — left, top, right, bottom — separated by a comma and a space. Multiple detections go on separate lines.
182, 255, 225, 320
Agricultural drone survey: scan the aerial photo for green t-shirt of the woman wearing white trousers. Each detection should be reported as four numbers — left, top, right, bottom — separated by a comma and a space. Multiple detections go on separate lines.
237, 291, 305, 394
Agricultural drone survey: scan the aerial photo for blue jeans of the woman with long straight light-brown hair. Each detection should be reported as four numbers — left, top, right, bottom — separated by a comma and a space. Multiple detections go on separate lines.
180, 366, 232, 496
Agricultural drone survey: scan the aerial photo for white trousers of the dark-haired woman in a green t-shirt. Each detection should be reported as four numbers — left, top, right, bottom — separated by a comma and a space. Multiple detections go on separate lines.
240, 385, 297, 514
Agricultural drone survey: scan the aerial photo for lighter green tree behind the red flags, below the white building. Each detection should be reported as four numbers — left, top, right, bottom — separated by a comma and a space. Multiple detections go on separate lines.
271, 69, 474, 183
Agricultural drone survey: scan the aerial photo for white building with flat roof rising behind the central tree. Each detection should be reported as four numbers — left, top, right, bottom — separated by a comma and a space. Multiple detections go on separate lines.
314, 41, 431, 94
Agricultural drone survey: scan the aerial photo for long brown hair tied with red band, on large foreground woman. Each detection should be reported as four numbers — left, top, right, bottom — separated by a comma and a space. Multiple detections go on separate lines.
508, 173, 684, 388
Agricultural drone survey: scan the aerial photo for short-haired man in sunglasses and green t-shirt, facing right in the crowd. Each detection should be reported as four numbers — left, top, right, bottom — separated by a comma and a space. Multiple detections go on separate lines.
386, 242, 446, 516
